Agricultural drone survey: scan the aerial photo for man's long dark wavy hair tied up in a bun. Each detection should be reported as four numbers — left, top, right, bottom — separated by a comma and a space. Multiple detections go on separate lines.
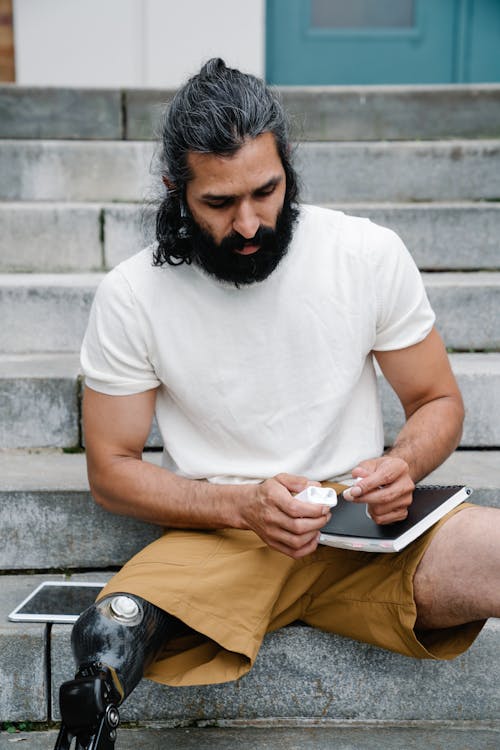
153, 58, 298, 266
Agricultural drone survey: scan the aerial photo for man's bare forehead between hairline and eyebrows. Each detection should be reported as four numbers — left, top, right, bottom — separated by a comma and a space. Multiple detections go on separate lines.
187, 133, 284, 195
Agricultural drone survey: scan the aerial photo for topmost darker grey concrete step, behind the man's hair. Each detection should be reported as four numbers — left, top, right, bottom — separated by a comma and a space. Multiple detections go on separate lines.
0, 84, 500, 140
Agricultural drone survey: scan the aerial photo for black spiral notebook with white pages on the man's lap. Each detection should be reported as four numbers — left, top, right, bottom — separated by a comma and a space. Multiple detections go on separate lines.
319, 485, 472, 552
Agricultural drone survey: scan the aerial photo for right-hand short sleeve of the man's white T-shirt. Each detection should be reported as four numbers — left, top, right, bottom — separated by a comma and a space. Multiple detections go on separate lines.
371, 225, 436, 351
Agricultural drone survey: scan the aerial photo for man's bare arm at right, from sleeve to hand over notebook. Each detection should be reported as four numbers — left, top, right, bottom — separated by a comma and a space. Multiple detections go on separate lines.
349, 329, 464, 523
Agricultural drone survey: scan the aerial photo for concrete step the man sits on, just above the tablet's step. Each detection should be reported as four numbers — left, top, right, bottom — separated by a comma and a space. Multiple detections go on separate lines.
0, 451, 500, 571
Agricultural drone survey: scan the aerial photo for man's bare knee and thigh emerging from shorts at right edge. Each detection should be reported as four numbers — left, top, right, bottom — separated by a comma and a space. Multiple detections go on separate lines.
413, 507, 500, 630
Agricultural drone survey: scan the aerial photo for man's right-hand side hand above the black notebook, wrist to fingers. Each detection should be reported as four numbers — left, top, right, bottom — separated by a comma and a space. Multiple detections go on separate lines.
344, 455, 415, 524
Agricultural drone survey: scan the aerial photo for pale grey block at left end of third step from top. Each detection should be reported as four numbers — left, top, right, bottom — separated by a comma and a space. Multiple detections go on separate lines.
0, 203, 103, 273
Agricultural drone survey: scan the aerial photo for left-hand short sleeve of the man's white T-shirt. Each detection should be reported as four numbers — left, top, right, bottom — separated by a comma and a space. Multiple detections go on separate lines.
81, 269, 160, 396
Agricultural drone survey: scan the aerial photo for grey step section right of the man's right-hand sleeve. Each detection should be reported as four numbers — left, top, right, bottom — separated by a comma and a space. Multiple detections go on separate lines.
423, 271, 500, 350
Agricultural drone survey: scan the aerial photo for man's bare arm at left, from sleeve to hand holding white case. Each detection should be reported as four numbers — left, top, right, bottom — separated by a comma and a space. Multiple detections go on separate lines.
83, 388, 328, 557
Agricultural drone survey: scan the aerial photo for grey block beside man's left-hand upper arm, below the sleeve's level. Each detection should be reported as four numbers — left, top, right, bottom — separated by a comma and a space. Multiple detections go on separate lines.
0, 354, 79, 448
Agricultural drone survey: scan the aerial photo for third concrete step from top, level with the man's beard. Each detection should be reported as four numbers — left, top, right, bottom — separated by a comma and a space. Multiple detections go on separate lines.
0, 202, 500, 273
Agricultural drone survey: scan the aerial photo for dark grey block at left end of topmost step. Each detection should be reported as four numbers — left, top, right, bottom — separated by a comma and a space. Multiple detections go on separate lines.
0, 84, 122, 139
